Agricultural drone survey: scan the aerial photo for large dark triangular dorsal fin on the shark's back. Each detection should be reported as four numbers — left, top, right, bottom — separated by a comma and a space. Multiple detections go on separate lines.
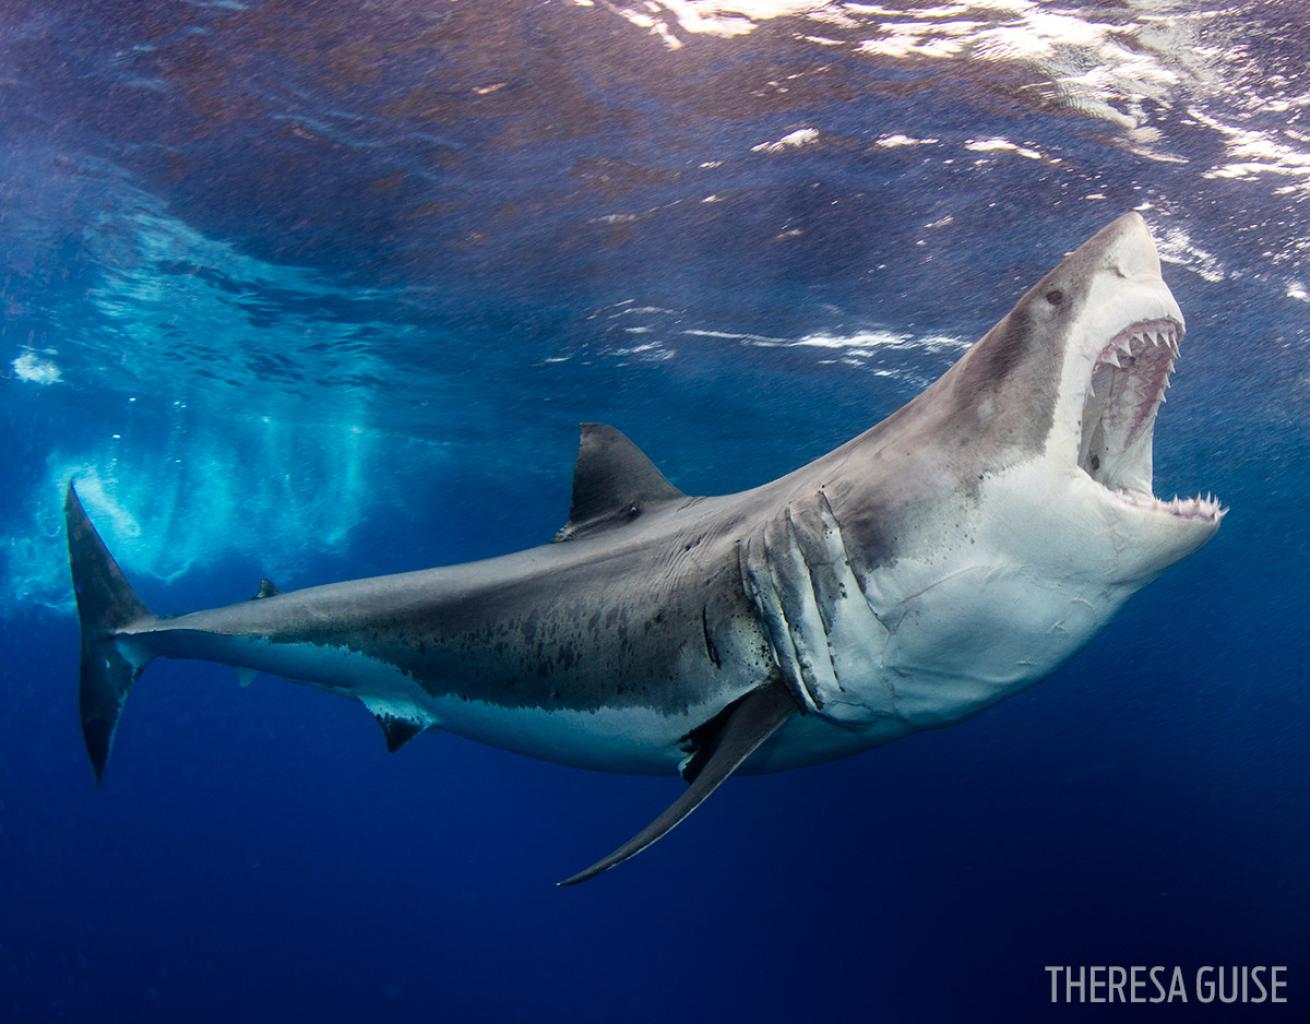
555, 423, 686, 541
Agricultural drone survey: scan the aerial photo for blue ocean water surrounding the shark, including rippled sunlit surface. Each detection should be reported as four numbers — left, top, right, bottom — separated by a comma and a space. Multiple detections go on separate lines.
0, 0, 1310, 1021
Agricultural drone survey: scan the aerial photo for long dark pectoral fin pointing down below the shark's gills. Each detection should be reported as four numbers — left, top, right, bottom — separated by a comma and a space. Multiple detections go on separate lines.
558, 678, 800, 885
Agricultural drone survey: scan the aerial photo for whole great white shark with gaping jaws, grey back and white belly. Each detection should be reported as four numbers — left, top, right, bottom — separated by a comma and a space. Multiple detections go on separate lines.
66, 213, 1226, 884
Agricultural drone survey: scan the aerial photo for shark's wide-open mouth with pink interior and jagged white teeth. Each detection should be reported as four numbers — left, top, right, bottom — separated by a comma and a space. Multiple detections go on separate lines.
1078, 318, 1227, 522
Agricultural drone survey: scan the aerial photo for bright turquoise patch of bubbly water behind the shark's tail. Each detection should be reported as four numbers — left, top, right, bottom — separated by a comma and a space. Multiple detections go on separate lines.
4, 416, 386, 609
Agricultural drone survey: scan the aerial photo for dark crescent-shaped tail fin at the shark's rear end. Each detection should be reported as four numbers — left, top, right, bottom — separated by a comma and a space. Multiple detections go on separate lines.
64, 483, 153, 782
